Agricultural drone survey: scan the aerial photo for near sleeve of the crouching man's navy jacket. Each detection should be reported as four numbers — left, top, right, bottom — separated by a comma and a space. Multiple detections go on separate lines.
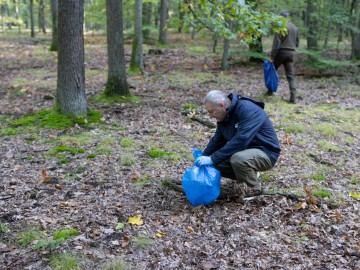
211, 105, 266, 164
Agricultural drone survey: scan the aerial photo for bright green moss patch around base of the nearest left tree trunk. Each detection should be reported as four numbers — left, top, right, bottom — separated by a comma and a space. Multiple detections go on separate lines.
11, 110, 101, 129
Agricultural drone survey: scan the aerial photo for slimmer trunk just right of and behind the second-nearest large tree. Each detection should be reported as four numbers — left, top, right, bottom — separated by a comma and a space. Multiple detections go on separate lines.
130, 0, 144, 71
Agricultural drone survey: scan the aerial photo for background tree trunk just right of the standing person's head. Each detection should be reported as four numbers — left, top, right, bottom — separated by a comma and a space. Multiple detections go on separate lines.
306, 0, 318, 50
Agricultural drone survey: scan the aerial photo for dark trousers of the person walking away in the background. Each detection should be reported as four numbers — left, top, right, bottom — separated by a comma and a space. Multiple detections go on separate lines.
274, 50, 296, 95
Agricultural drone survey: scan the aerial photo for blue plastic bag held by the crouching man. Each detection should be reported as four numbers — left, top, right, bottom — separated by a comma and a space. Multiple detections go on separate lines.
182, 149, 220, 206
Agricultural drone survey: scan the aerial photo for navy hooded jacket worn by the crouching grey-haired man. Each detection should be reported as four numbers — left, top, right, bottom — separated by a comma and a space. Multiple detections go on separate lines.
203, 93, 280, 165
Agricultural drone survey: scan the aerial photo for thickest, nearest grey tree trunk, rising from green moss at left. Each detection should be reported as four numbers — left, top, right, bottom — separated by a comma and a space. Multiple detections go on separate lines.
56, 0, 87, 116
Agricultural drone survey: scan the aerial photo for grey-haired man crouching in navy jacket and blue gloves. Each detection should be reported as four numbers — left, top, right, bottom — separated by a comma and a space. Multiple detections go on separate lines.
195, 90, 280, 191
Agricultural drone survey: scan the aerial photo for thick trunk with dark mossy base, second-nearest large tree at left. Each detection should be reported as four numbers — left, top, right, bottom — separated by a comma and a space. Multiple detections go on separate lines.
105, 0, 130, 96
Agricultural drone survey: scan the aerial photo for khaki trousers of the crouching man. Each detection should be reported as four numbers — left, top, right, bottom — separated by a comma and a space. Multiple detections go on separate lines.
215, 148, 274, 187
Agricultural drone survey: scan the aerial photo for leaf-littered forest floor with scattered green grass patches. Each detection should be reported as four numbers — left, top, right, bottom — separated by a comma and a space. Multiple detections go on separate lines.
0, 32, 360, 270
